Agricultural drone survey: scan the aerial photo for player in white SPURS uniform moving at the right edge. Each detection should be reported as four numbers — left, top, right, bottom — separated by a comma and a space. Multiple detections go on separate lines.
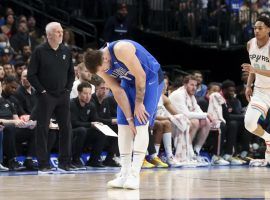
241, 17, 270, 164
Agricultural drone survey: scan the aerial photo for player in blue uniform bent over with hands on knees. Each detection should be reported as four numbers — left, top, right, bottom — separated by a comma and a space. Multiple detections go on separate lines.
84, 40, 164, 189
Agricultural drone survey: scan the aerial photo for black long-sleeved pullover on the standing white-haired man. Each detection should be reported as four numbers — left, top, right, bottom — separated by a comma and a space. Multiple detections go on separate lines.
27, 42, 75, 96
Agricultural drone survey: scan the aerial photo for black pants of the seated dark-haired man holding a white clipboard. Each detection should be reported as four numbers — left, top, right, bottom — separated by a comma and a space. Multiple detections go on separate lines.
72, 127, 106, 162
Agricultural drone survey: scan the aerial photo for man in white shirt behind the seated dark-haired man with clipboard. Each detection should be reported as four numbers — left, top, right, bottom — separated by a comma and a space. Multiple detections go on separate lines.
70, 62, 95, 99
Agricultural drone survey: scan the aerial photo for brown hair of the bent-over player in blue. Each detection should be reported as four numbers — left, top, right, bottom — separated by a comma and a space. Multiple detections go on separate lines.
84, 48, 102, 74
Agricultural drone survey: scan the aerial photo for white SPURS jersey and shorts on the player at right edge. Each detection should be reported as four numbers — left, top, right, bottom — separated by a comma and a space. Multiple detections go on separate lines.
249, 38, 270, 118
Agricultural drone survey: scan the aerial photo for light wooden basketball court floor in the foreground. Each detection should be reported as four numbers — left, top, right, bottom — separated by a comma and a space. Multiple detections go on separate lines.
0, 166, 270, 200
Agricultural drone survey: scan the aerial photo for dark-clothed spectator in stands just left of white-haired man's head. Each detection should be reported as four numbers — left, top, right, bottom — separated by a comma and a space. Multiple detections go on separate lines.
10, 22, 38, 53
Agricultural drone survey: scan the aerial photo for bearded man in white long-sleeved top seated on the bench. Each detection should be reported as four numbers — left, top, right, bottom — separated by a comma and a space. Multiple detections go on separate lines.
169, 75, 212, 163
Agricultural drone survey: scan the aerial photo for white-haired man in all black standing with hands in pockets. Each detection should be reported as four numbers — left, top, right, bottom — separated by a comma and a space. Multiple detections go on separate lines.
27, 22, 75, 171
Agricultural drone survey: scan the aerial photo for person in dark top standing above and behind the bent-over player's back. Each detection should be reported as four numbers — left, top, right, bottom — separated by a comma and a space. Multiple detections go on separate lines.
103, 3, 132, 42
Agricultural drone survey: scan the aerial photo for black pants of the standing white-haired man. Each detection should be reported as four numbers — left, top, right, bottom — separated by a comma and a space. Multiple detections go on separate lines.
34, 92, 72, 166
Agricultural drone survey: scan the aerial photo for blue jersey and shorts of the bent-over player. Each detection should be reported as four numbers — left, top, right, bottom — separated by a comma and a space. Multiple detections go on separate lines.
104, 40, 164, 127
